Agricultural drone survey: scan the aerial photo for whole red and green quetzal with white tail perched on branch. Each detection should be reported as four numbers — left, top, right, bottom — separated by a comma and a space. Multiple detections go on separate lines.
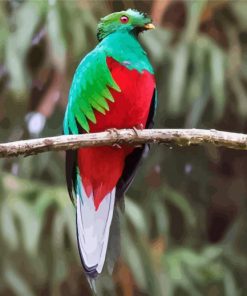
64, 9, 156, 278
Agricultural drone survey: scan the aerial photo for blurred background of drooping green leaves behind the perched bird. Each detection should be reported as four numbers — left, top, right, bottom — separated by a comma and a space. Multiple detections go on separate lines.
0, 0, 247, 296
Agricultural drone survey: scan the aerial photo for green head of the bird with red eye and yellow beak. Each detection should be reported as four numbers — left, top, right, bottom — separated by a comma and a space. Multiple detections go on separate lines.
97, 9, 155, 41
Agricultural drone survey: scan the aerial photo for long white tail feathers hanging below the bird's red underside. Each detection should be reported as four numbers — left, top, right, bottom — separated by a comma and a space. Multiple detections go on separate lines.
76, 184, 115, 277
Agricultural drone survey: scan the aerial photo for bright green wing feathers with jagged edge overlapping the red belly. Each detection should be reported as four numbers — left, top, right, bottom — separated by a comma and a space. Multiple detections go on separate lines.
64, 50, 121, 134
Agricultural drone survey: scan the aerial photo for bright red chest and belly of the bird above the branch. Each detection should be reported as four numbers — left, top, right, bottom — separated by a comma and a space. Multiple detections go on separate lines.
90, 58, 155, 132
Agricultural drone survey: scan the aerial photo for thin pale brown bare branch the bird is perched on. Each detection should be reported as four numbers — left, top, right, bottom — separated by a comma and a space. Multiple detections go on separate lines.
0, 129, 247, 158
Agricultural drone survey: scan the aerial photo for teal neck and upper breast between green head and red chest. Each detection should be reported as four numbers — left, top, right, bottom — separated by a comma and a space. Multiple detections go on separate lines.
99, 32, 153, 74
